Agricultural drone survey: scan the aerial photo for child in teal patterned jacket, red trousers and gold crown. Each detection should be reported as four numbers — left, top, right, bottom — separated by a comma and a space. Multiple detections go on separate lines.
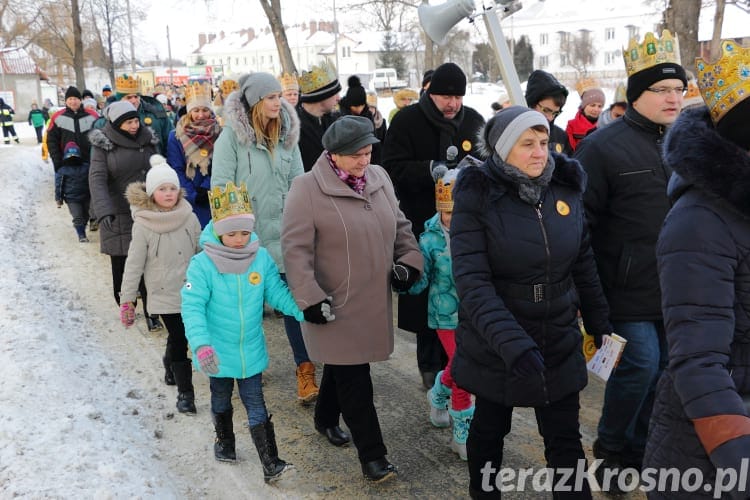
408, 161, 474, 460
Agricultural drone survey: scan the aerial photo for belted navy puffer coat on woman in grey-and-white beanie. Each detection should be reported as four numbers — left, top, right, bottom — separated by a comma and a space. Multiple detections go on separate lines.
451, 154, 612, 406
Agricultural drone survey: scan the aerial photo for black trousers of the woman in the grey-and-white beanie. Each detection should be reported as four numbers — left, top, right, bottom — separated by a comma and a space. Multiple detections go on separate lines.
466, 392, 591, 499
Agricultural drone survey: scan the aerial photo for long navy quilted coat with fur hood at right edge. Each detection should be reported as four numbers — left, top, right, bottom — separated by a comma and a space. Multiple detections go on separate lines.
644, 108, 750, 498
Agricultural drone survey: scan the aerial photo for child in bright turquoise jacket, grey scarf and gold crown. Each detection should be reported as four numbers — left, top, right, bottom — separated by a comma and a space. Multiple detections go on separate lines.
182, 182, 328, 482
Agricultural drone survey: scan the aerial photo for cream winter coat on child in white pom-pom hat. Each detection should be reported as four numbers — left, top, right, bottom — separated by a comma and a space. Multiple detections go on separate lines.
120, 182, 201, 314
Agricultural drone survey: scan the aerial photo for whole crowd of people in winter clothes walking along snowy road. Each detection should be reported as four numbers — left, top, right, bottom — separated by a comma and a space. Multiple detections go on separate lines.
19, 31, 750, 498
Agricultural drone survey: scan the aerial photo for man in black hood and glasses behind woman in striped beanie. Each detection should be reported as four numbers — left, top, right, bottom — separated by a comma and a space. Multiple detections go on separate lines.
526, 69, 573, 156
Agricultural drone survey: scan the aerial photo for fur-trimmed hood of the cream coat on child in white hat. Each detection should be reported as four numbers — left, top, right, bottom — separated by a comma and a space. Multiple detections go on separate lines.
125, 182, 193, 234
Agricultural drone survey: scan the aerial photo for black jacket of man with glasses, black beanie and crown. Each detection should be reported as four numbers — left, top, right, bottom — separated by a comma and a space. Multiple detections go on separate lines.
575, 107, 672, 321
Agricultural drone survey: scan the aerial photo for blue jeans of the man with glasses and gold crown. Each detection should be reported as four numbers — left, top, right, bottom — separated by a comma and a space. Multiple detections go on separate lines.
598, 321, 667, 460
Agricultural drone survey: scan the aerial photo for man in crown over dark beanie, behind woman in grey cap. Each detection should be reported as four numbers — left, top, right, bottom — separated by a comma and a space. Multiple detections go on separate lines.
297, 64, 341, 172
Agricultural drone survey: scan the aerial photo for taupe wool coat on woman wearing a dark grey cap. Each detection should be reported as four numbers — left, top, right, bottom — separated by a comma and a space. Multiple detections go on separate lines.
281, 155, 423, 365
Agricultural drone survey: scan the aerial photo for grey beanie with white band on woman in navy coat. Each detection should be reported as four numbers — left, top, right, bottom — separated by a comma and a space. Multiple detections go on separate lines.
482, 106, 549, 161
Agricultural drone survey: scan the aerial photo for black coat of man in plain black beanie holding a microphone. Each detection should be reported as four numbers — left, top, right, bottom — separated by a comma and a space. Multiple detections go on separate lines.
383, 93, 484, 333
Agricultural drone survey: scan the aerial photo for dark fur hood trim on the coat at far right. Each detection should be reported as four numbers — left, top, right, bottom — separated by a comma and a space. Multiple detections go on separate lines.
664, 107, 750, 216
